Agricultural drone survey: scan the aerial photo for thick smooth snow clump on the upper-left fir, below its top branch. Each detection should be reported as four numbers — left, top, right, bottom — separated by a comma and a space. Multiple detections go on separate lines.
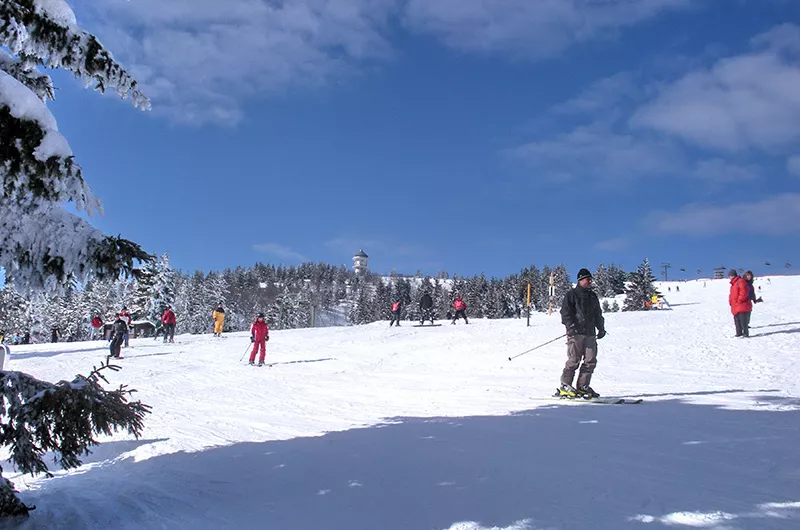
0, 70, 72, 161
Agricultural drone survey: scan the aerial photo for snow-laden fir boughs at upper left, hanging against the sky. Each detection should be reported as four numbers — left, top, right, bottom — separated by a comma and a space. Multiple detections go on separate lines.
0, 0, 150, 290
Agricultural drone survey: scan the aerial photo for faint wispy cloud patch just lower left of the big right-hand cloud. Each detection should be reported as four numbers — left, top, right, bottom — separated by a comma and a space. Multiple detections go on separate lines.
509, 124, 683, 182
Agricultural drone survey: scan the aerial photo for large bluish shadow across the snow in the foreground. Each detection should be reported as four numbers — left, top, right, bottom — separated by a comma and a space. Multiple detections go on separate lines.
12, 391, 800, 530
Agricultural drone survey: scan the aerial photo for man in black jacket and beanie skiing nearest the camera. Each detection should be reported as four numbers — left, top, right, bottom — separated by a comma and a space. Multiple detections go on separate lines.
557, 269, 606, 399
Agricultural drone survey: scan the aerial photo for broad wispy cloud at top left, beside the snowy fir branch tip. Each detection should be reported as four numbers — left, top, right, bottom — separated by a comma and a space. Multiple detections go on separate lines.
78, 0, 395, 123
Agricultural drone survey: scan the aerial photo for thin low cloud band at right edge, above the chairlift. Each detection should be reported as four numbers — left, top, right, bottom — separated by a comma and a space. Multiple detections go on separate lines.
646, 193, 800, 237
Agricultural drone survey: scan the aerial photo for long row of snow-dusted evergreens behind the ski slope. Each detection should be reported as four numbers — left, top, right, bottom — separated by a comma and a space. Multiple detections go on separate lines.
0, 254, 655, 342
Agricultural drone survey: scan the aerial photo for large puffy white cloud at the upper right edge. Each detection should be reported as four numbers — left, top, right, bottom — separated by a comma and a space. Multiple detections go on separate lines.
631, 24, 800, 153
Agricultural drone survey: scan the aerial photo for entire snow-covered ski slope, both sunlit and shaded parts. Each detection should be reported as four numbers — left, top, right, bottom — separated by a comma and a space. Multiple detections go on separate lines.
3, 276, 800, 530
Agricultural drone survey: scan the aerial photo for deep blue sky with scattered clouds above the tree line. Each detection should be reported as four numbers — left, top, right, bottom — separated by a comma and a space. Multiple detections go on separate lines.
52, 0, 800, 276
